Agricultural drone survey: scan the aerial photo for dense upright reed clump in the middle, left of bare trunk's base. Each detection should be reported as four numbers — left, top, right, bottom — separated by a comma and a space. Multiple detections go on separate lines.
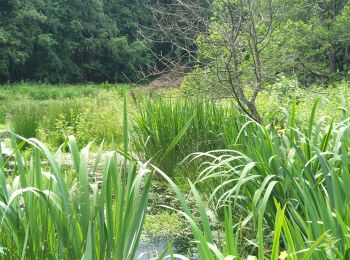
132, 98, 246, 175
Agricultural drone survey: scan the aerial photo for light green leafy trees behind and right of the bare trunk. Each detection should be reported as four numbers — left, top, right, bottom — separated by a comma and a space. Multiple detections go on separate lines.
183, 0, 350, 106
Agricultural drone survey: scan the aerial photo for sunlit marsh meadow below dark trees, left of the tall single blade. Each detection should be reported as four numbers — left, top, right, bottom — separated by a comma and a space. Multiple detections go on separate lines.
2, 84, 128, 147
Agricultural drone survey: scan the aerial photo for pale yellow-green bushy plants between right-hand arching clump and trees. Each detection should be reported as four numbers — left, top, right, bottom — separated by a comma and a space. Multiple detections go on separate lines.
257, 78, 350, 128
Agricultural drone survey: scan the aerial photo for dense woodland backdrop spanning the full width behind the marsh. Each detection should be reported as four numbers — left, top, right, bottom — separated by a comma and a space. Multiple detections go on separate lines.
0, 0, 350, 84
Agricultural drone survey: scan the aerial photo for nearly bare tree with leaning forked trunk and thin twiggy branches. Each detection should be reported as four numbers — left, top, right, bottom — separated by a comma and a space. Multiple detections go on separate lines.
141, 0, 285, 122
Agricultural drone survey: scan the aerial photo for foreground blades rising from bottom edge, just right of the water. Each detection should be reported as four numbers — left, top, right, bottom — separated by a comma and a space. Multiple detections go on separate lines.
155, 167, 326, 260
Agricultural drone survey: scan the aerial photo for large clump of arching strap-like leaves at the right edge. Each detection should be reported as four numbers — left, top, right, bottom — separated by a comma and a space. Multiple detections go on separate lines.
186, 103, 350, 259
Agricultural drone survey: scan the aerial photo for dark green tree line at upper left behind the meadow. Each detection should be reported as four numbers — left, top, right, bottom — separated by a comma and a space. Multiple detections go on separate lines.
0, 0, 154, 83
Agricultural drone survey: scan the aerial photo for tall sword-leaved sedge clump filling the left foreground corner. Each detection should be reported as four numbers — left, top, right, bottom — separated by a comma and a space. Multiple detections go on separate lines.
0, 88, 151, 259
